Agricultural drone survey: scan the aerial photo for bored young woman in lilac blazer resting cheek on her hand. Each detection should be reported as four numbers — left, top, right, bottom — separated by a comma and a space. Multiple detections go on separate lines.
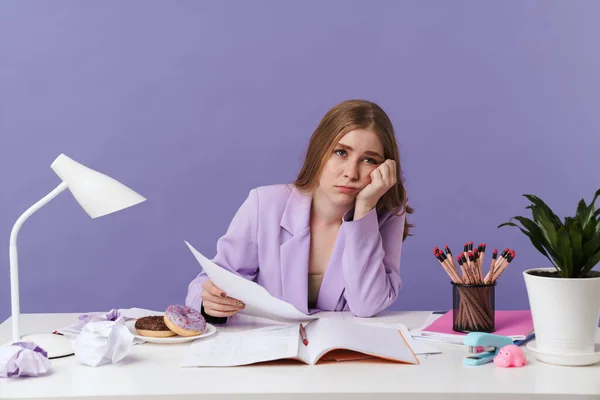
186, 100, 412, 323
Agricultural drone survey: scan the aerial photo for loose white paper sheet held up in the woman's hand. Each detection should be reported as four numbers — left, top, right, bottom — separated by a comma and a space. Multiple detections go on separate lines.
185, 242, 317, 321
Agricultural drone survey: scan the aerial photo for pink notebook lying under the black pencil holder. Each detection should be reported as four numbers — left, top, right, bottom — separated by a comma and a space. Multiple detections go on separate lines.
421, 310, 533, 341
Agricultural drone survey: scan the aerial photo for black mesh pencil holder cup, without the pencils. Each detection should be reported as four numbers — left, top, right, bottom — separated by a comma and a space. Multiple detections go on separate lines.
452, 283, 496, 333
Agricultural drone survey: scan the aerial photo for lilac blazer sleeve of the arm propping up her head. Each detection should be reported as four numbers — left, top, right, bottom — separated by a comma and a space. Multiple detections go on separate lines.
341, 209, 406, 317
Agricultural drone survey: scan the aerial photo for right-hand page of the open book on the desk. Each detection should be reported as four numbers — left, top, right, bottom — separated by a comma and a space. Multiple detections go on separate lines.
306, 318, 418, 364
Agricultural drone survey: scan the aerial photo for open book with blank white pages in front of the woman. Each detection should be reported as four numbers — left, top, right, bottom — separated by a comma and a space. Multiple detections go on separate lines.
181, 318, 419, 367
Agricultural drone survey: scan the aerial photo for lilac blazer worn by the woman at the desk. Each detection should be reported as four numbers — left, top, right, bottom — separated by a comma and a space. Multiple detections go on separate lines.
186, 185, 405, 317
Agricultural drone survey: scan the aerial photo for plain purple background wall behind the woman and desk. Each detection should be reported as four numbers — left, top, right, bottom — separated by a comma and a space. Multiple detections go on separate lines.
0, 0, 600, 320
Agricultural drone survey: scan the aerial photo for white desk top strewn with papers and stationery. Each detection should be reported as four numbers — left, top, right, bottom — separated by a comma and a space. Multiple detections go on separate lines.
0, 312, 600, 400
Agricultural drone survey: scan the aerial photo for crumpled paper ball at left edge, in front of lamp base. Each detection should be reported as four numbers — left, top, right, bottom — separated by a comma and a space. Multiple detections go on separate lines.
0, 342, 50, 378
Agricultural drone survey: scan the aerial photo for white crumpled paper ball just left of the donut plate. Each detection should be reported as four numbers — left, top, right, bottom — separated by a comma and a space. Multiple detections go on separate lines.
74, 317, 135, 367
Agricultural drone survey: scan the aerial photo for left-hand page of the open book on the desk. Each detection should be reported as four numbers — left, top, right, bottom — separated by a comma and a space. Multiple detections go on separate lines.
181, 324, 304, 367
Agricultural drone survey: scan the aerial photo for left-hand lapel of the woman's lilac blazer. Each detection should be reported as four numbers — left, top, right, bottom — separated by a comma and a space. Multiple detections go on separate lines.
279, 187, 312, 313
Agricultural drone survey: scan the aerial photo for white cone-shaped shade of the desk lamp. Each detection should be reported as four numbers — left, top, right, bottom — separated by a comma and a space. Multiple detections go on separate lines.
50, 154, 146, 218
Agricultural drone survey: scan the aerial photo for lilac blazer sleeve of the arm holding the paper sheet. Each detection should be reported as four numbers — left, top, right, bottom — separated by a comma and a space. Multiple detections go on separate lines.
185, 189, 258, 323
